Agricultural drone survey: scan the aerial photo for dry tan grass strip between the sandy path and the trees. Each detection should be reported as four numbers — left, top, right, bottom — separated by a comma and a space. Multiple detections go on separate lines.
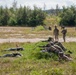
0, 26, 76, 38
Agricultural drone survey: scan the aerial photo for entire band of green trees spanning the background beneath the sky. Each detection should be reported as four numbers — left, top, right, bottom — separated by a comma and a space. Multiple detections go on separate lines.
0, 0, 76, 27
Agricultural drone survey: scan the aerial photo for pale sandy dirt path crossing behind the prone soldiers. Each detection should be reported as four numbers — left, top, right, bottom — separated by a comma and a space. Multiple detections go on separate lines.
0, 37, 76, 43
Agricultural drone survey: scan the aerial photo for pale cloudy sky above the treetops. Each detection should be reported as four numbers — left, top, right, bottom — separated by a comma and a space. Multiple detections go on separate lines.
0, 0, 76, 9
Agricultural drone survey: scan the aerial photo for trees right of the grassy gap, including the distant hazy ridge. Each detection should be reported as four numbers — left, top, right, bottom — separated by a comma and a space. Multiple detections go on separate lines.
46, 5, 76, 26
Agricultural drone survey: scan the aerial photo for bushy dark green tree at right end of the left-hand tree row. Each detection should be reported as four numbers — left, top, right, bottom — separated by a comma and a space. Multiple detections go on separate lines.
30, 6, 45, 27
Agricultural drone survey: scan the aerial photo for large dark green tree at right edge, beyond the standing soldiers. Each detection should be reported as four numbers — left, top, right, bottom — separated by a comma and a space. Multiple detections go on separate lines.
60, 6, 76, 26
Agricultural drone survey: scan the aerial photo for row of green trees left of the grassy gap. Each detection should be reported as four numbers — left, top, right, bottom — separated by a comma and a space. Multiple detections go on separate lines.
0, 3, 46, 27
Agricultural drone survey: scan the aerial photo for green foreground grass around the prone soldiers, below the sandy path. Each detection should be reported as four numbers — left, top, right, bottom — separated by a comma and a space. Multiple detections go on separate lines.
0, 42, 76, 75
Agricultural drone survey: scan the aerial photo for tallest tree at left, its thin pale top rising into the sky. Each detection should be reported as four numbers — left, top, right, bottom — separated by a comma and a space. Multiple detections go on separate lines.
8, 0, 17, 26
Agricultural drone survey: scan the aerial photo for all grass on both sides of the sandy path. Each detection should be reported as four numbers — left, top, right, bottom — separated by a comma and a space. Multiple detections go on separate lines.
0, 26, 76, 75
